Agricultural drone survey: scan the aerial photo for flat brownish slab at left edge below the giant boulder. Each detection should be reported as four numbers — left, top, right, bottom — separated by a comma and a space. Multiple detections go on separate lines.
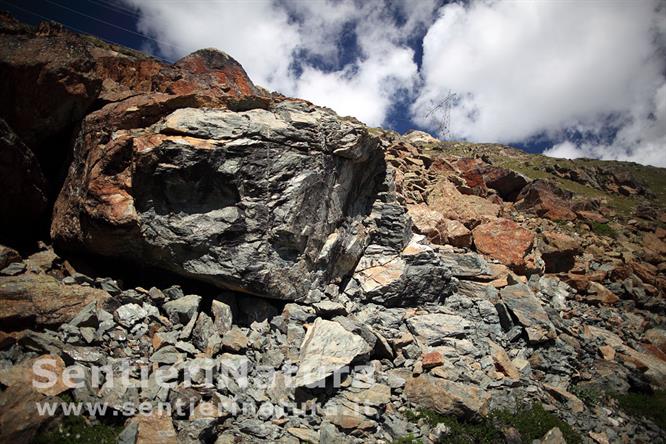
0, 273, 109, 325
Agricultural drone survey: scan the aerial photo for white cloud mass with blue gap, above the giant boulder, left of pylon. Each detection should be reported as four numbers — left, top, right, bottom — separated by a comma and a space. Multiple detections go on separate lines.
122, 0, 437, 126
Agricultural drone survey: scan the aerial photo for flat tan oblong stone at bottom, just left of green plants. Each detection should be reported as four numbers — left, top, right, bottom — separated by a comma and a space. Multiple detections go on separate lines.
404, 375, 489, 417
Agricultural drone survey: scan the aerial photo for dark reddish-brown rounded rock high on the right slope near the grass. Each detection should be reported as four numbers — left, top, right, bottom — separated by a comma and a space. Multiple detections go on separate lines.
516, 180, 576, 221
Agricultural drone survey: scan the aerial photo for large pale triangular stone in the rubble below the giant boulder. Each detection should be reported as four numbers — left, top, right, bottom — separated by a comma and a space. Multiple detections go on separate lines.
294, 318, 371, 387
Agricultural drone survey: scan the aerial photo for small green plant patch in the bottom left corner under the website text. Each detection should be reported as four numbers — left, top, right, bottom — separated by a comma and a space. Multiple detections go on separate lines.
32, 416, 123, 444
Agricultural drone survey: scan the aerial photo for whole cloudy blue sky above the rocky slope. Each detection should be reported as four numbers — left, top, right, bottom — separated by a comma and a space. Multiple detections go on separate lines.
5, 0, 666, 166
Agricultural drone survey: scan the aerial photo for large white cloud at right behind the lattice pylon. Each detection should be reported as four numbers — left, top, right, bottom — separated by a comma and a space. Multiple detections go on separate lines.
412, 0, 666, 164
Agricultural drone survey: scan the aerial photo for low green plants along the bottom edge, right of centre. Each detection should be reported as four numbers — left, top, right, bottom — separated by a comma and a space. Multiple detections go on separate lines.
405, 403, 582, 444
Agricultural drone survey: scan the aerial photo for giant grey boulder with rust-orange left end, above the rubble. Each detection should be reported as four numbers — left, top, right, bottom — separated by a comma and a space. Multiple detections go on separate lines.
52, 102, 383, 300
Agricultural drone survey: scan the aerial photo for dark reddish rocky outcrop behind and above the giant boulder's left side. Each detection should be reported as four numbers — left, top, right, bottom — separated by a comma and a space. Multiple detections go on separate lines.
0, 14, 270, 243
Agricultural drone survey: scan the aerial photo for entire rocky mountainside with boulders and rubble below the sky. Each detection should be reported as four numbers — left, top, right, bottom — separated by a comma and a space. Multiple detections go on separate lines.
0, 15, 666, 444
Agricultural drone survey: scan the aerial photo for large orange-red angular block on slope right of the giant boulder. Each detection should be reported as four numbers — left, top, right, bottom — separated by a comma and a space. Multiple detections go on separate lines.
472, 219, 534, 271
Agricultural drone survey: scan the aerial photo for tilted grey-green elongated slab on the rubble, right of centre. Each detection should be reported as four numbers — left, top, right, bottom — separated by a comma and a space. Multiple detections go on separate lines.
500, 284, 556, 342
